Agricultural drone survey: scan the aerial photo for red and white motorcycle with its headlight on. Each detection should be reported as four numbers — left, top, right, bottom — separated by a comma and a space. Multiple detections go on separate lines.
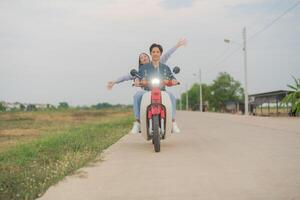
130, 67, 180, 152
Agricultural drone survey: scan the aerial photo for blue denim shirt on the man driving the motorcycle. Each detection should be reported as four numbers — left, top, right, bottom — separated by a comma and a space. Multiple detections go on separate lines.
138, 62, 176, 91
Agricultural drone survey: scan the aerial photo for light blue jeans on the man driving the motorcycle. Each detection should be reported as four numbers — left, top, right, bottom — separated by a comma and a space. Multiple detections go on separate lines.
133, 90, 176, 120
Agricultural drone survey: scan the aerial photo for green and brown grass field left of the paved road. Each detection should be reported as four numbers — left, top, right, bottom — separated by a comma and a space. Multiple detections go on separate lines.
0, 109, 133, 200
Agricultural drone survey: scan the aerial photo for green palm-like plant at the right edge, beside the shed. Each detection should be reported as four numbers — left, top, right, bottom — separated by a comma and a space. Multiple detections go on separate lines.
282, 76, 300, 114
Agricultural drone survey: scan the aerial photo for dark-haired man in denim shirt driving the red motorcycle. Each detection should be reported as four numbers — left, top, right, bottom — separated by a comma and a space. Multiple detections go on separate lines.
131, 44, 180, 133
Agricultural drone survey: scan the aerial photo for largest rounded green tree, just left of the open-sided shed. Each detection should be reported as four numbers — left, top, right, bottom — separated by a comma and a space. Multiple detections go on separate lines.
209, 72, 244, 111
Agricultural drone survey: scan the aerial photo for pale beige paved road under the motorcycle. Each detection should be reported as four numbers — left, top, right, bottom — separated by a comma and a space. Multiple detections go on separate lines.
41, 112, 300, 200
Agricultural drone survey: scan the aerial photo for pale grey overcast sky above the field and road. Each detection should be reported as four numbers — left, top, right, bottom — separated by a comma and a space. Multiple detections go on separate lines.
0, 0, 300, 105
